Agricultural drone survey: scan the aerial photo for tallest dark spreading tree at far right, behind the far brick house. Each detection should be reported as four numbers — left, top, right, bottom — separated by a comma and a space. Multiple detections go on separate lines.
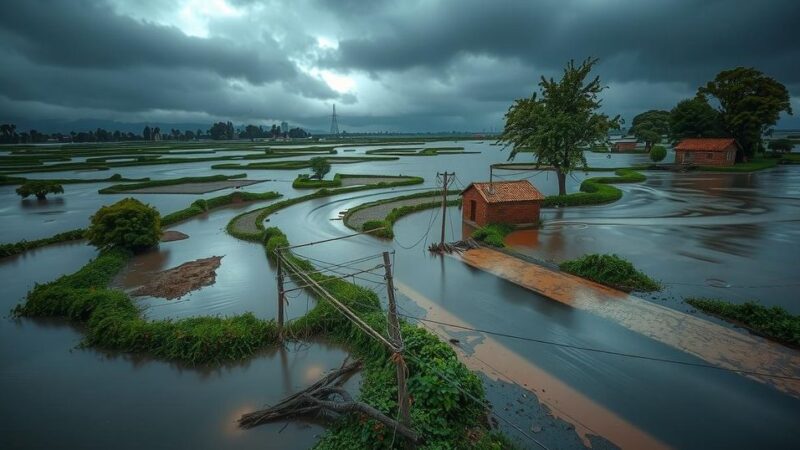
698, 67, 792, 160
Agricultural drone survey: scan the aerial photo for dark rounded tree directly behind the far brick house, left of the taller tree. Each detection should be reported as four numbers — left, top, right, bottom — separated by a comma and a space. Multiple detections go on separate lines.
669, 97, 725, 141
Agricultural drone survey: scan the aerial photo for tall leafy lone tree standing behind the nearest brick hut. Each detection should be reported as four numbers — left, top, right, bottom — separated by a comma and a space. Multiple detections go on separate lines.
500, 58, 621, 195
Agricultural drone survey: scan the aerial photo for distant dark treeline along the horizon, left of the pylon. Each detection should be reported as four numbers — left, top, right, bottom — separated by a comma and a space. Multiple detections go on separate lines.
0, 122, 309, 144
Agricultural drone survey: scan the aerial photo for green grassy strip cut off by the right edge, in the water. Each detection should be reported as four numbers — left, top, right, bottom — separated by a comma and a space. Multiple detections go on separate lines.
686, 298, 800, 348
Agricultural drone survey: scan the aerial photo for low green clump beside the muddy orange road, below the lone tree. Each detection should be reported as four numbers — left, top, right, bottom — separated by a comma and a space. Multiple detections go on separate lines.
559, 254, 661, 292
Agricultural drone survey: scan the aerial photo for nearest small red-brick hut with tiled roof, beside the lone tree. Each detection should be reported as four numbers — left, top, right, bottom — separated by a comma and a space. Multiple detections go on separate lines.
461, 180, 544, 227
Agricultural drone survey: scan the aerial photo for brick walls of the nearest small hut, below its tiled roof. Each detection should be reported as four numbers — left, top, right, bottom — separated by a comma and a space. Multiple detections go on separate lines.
461, 189, 541, 227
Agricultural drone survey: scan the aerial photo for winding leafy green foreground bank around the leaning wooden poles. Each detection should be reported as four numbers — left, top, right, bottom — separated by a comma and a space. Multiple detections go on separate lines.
14, 224, 510, 449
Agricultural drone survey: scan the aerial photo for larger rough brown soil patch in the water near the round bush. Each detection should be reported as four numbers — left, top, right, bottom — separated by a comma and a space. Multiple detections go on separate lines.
133, 256, 222, 300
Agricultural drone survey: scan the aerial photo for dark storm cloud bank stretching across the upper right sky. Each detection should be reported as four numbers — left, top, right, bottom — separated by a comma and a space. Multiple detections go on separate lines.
327, 0, 800, 84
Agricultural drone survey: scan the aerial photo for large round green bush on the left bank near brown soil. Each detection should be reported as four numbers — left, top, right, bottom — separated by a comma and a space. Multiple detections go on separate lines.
86, 198, 161, 251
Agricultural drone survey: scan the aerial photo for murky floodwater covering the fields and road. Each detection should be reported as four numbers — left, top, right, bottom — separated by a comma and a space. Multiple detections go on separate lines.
0, 142, 800, 448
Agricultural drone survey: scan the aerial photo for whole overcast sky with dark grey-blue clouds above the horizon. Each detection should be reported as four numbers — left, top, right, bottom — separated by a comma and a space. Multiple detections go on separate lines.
0, 0, 800, 131
